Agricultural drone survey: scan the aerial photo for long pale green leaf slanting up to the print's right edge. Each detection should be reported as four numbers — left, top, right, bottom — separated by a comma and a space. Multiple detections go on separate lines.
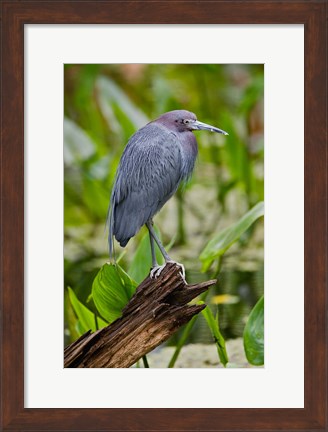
199, 201, 264, 271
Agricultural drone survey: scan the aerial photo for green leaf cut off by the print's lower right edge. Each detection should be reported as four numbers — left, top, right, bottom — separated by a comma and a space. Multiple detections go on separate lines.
244, 296, 264, 366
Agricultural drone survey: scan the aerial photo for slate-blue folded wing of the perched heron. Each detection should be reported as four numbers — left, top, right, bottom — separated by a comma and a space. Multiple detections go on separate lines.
110, 124, 181, 246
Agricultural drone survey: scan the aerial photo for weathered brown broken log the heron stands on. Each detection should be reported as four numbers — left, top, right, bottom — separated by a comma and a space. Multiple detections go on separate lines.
64, 263, 216, 368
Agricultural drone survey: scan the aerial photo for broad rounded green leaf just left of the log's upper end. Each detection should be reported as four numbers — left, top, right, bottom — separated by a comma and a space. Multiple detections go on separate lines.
92, 263, 137, 323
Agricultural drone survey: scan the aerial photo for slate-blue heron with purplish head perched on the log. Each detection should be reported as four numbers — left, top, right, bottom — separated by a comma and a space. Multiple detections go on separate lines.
108, 110, 228, 280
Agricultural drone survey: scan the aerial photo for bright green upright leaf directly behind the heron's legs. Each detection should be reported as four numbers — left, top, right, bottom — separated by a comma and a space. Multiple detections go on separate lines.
128, 227, 164, 283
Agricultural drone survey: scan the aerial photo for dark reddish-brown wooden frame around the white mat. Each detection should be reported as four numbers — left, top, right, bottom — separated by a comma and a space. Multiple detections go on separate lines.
1, 0, 328, 431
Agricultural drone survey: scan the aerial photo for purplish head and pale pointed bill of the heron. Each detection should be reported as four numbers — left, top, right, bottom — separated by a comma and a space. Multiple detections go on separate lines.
155, 110, 228, 135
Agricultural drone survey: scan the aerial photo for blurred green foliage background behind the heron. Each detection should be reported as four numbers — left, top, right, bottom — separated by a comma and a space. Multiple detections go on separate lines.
64, 64, 264, 364
